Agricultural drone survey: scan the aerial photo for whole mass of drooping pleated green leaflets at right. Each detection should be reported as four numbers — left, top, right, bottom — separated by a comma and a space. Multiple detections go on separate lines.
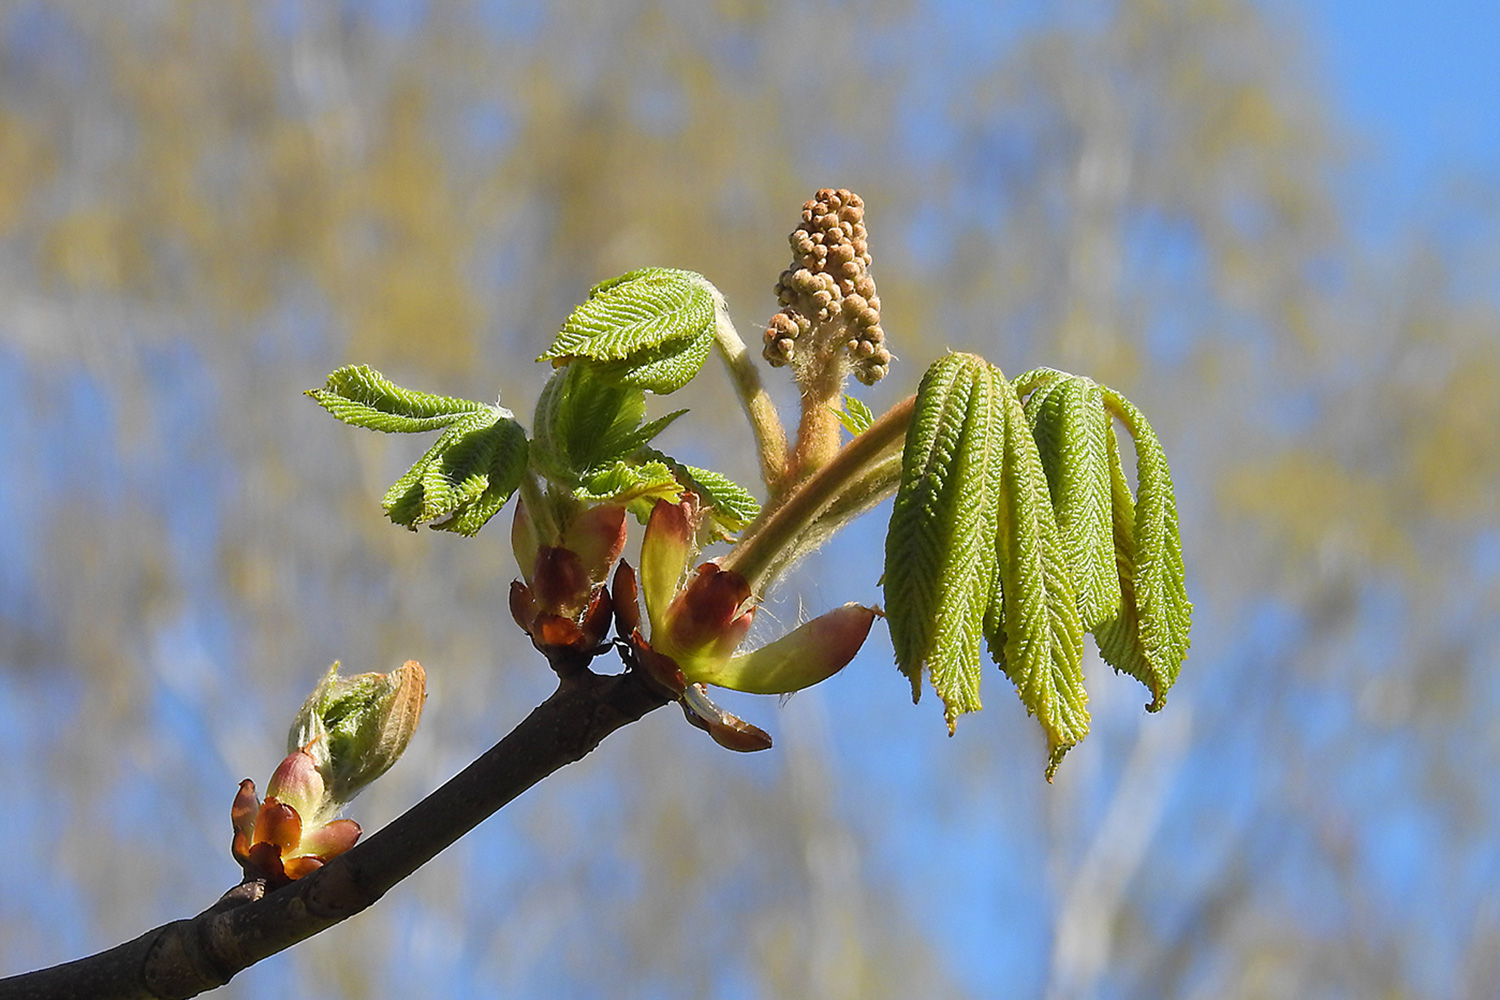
885, 354, 1193, 780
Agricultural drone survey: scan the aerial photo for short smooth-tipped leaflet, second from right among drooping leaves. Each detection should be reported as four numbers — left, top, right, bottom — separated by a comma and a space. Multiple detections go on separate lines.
1026, 376, 1121, 628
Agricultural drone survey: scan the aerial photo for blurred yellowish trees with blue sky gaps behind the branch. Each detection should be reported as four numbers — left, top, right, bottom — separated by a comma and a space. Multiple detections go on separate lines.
0, 0, 1500, 999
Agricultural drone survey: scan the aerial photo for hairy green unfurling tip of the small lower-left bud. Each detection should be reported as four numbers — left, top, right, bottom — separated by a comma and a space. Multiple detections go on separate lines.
288, 660, 428, 819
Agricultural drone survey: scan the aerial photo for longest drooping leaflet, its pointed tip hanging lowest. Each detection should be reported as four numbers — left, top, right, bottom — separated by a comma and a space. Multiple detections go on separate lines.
986, 376, 1089, 781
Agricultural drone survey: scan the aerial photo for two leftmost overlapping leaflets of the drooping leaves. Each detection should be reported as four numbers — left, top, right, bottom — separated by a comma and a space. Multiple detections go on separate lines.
885, 354, 1019, 733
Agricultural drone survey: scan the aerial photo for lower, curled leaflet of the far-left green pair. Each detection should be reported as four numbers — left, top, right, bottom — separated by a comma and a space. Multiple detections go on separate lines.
383, 409, 527, 535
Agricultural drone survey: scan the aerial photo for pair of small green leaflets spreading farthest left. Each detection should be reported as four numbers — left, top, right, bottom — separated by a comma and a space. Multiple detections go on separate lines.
308, 364, 527, 535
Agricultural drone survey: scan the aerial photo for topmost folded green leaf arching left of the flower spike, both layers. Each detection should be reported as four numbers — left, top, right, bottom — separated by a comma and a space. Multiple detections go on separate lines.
537, 267, 716, 393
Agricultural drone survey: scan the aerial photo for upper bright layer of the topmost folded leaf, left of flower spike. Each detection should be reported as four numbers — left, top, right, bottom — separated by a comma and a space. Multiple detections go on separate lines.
537, 267, 716, 370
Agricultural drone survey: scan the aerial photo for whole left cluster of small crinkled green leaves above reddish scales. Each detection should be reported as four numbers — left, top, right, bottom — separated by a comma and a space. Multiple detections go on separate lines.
308, 268, 759, 535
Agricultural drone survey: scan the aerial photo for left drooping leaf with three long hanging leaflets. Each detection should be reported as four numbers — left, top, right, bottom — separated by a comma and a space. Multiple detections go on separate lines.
885, 354, 1089, 777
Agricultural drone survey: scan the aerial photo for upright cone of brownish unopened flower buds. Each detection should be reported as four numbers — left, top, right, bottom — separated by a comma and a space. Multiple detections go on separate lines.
764, 187, 891, 385
